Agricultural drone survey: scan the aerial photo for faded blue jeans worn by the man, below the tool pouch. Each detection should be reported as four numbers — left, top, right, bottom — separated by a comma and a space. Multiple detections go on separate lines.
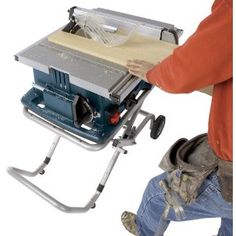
136, 172, 232, 236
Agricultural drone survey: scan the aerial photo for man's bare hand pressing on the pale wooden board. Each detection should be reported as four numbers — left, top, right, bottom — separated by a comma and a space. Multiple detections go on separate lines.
126, 60, 155, 82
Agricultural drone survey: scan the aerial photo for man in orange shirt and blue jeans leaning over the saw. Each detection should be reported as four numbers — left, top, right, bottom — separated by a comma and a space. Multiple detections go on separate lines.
122, 0, 232, 236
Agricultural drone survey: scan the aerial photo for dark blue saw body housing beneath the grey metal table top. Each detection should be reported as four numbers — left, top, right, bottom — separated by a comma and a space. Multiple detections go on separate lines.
21, 69, 151, 143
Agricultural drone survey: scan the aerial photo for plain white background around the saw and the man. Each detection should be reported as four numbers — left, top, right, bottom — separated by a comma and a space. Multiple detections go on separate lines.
0, 0, 220, 236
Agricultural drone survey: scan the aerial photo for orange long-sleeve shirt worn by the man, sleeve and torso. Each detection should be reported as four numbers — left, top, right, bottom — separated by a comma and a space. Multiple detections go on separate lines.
147, 0, 233, 161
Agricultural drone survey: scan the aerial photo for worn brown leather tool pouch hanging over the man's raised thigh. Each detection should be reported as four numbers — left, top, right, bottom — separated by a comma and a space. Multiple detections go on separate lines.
159, 134, 218, 204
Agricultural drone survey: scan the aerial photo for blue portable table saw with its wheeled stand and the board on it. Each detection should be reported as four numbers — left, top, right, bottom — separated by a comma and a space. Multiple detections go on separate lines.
8, 7, 182, 212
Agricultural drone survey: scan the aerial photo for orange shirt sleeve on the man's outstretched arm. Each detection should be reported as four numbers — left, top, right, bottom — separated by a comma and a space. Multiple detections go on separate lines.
147, 0, 232, 93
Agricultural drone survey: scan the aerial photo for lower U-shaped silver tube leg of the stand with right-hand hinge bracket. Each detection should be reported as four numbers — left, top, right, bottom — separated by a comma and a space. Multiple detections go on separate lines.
8, 106, 159, 213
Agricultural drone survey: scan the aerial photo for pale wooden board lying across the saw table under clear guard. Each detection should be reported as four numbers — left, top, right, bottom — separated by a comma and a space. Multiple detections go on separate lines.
48, 30, 177, 66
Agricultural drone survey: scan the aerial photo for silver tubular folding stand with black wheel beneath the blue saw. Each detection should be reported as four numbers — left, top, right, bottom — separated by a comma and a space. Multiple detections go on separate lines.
8, 91, 165, 213
